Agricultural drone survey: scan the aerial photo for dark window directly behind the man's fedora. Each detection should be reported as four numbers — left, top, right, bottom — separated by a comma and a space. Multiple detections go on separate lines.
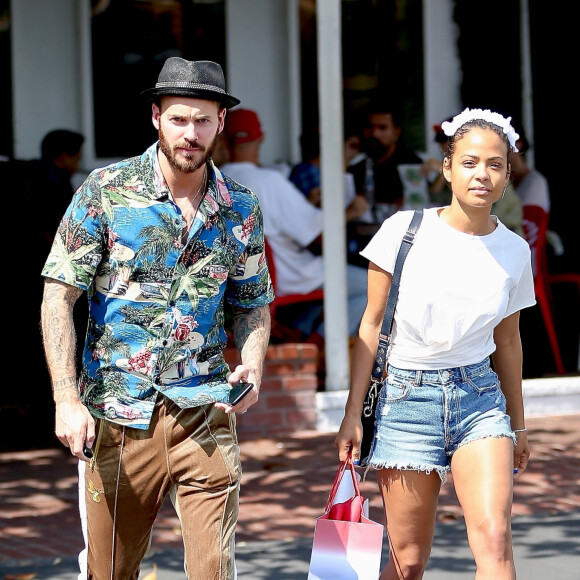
92, 0, 226, 158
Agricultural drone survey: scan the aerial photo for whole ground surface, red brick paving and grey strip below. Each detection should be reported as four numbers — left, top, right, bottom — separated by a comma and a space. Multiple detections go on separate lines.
0, 411, 580, 580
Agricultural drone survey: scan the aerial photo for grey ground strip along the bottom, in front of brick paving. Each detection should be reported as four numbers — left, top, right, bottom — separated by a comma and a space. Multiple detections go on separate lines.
0, 511, 580, 580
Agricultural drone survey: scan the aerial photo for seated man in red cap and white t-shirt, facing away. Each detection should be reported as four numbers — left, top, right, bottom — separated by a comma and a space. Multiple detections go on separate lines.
221, 109, 367, 346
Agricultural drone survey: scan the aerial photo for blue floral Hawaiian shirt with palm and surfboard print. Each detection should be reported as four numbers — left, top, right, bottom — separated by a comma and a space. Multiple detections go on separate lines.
42, 144, 274, 429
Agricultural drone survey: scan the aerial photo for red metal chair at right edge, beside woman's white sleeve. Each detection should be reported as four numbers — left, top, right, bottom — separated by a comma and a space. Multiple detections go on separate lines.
522, 205, 580, 375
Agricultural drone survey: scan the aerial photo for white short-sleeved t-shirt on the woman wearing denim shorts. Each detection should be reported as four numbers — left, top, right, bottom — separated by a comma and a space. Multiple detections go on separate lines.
361, 208, 535, 370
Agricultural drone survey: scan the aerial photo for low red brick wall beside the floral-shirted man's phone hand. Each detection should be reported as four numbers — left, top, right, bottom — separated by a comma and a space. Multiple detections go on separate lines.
225, 343, 318, 440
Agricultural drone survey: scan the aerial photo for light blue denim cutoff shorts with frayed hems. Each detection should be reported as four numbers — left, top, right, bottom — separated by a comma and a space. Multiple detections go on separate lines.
369, 358, 516, 483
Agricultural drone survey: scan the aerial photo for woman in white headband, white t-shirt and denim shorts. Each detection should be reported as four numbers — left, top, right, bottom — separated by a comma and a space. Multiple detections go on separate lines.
336, 109, 535, 580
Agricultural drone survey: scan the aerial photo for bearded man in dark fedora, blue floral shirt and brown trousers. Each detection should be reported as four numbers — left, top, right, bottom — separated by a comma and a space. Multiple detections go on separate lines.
42, 57, 273, 580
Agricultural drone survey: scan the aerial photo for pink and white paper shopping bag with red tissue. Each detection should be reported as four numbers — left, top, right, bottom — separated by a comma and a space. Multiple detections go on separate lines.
308, 456, 384, 580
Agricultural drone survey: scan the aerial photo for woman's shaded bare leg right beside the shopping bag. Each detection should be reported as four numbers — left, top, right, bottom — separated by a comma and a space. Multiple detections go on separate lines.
377, 469, 441, 580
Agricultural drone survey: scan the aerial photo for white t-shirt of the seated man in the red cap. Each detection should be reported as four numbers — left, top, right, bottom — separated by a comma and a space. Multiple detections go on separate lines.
220, 162, 324, 296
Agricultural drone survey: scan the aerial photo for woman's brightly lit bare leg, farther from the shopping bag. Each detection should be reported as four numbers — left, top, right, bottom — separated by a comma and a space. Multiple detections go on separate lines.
451, 437, 516, 580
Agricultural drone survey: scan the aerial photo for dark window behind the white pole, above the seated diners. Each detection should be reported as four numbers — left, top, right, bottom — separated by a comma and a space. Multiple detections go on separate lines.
300, 0, 425, 150
